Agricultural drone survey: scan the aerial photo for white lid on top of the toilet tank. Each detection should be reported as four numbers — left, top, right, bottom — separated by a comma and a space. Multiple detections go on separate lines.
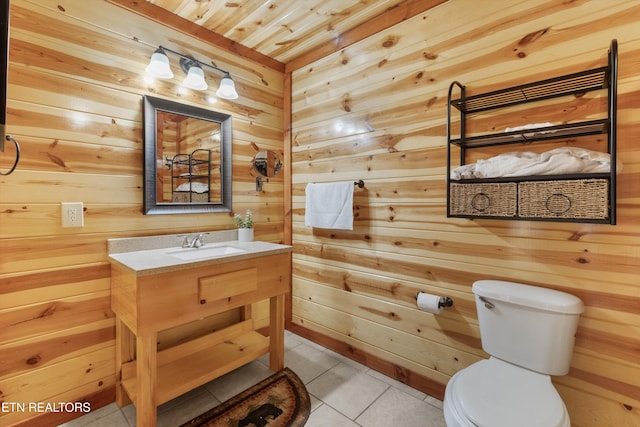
471, 280, 584, 314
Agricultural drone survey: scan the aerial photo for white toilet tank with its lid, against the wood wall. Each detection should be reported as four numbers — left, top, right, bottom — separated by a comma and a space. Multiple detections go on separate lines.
472, 280, 584, 375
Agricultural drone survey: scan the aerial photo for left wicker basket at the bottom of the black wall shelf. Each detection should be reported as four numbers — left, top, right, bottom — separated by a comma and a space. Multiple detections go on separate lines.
449, 182, 518, 217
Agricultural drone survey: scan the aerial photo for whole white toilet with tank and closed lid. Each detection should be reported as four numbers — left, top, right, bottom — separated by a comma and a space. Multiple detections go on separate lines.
444, 280, 584, 427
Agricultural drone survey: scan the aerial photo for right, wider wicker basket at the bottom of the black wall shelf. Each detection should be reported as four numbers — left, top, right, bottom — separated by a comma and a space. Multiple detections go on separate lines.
518, 179, 609, 219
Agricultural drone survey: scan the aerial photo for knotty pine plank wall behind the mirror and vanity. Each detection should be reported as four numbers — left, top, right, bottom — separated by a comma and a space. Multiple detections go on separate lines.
0, 0, 284, 425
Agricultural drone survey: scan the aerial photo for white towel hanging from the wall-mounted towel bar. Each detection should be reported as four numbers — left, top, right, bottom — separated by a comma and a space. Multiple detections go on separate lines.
304, 182, 353, 230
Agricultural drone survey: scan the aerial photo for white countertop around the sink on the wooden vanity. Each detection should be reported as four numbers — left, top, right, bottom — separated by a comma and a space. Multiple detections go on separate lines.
109, 240, 293, 276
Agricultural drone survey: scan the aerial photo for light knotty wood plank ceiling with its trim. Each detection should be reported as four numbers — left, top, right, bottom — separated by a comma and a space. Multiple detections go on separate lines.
109, 0, 444, 64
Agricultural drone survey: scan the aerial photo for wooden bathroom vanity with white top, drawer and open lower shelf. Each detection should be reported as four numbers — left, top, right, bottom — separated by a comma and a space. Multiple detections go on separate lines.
109, 242, 291, 427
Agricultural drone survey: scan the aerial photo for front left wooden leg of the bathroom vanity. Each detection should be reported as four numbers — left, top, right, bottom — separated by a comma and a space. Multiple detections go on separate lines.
136, 331, 158, 427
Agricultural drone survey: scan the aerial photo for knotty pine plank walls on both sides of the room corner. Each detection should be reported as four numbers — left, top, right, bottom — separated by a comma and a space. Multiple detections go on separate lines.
0, 0, 640, 427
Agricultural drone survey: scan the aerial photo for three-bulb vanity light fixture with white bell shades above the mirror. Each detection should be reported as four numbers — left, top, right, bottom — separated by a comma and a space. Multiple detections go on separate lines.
145, 46, 238, 99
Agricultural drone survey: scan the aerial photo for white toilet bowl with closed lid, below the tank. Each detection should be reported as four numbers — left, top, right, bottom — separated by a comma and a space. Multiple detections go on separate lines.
445, 357, 570, 427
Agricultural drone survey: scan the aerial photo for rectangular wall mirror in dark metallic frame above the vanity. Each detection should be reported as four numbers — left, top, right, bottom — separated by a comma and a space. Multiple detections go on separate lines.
143, 96, 231, 215
